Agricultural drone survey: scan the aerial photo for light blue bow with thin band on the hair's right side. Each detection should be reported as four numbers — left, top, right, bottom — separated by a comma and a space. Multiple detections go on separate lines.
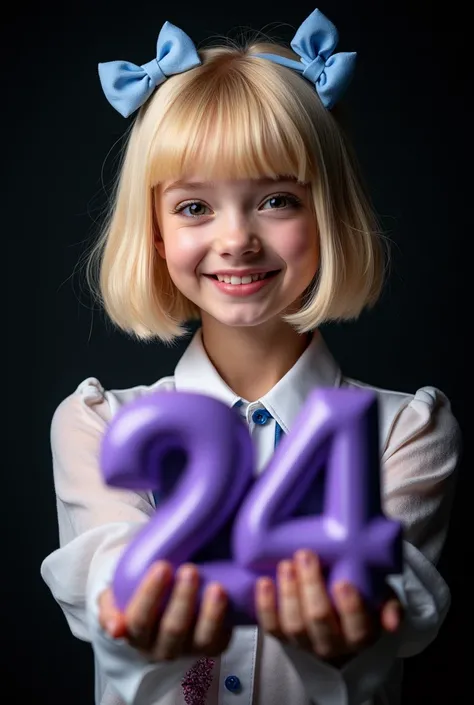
253, 10, 357, 109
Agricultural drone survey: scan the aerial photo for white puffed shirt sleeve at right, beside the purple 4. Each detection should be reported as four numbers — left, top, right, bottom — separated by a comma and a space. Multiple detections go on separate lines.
285, 387, 461, 705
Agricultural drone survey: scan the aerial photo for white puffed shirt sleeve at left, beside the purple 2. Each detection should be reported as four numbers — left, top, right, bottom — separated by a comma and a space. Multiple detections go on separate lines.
41, 378, 193, 705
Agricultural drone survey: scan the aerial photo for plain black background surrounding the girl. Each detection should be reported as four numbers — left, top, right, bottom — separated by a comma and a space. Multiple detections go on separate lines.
1, 0, 472, 705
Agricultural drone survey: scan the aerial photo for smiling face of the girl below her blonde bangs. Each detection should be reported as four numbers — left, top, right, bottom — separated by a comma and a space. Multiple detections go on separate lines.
155, 175, 319, 326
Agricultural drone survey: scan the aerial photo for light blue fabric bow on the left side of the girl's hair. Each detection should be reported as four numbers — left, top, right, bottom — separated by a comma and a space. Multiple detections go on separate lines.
99, 22, 201, 117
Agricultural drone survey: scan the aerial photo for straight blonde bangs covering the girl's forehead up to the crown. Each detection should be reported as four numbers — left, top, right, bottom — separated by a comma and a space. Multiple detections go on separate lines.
144, 50, 314, 187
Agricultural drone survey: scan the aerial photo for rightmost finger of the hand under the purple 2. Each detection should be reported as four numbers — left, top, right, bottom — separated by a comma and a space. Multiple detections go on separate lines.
193, 583, 231, 656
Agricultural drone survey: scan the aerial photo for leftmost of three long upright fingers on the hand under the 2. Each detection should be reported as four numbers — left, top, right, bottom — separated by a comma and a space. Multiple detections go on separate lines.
125, 561, 172, 649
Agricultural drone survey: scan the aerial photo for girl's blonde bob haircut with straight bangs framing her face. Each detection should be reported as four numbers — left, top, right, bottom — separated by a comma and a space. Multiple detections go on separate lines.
87, 40, 385, 342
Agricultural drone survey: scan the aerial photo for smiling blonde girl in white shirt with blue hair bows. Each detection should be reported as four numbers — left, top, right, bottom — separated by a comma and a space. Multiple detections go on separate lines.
42, 10, 459, 705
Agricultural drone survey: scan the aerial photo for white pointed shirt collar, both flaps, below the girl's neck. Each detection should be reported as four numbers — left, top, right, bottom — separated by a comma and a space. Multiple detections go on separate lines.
174, 329, 341, 433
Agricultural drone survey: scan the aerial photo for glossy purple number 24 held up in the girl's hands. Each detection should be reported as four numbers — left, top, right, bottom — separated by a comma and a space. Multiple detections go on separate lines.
101, 389, 402, 624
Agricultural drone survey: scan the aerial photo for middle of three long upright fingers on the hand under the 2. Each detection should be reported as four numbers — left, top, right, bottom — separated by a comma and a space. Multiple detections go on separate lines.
154, 564, 199, 661
